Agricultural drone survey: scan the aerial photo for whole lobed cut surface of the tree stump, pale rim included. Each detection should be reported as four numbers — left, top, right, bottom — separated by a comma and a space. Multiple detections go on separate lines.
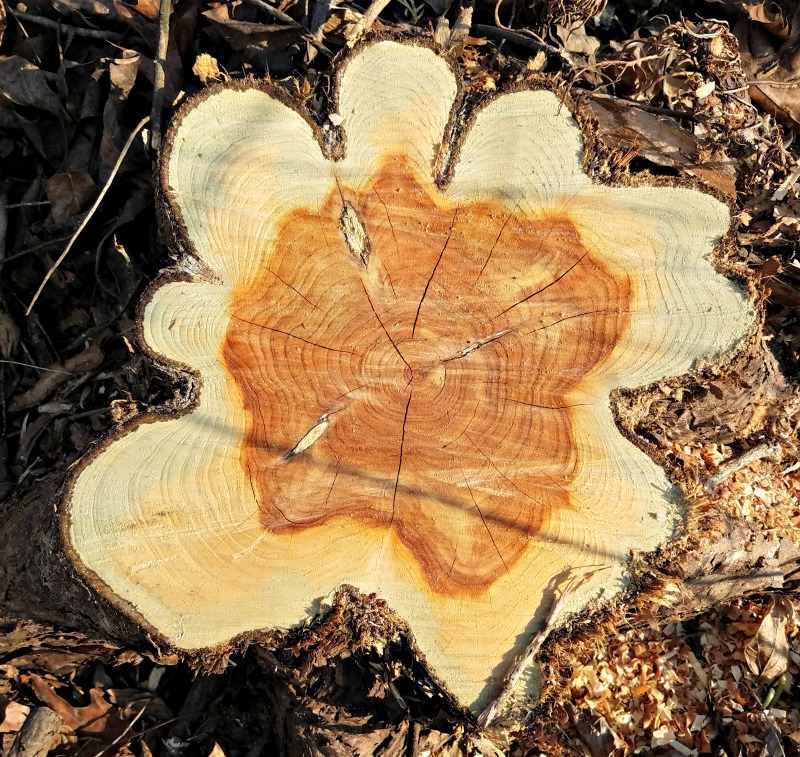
63, 40, 757, 707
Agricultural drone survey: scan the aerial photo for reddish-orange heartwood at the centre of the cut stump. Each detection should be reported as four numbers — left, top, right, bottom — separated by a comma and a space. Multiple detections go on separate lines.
223, 158, 630, 596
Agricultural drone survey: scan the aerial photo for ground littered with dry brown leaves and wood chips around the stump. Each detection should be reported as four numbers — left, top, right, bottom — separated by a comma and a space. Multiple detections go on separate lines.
0, 0, 800, 757
